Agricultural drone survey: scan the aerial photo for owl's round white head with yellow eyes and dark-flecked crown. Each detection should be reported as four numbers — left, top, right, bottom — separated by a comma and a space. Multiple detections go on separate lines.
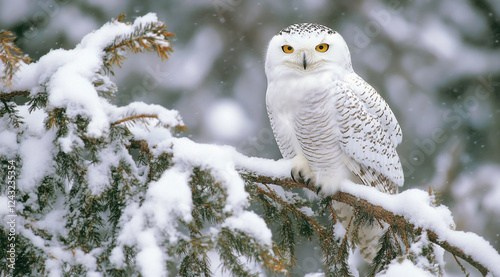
266, 23, 352, 76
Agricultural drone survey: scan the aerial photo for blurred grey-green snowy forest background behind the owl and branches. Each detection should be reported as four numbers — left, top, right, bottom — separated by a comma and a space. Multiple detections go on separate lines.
0, 0, 500, 272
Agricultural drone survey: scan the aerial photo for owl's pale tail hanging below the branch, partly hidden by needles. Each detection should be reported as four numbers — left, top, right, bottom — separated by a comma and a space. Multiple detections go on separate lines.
333, 201, 384, 263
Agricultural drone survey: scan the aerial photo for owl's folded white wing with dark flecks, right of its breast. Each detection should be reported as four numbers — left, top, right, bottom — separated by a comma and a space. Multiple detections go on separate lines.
331, 81, 404, 193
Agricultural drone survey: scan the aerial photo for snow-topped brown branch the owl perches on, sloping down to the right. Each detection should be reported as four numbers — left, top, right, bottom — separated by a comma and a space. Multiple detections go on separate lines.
244, 174, 500, 276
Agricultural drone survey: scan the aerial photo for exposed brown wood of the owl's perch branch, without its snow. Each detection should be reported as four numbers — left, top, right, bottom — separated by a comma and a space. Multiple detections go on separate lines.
248, 174, 489, 276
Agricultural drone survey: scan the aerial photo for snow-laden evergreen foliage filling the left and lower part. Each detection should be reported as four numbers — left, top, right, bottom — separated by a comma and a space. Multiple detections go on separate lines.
0, 13, 498, 276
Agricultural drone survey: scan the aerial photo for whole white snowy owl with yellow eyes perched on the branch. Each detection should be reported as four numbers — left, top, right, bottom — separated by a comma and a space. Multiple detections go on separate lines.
265, 23, 403, 260
